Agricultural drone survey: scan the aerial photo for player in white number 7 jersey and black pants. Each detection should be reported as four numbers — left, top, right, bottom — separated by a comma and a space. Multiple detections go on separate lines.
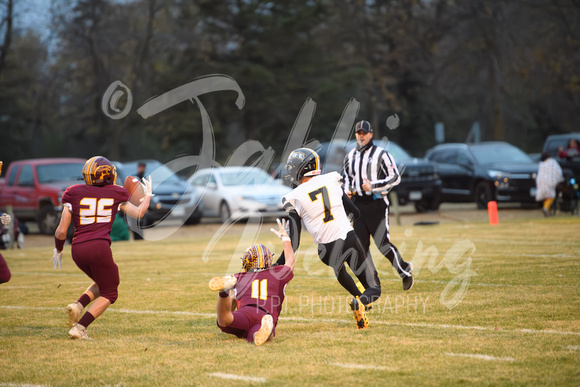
278, 148, 381, 329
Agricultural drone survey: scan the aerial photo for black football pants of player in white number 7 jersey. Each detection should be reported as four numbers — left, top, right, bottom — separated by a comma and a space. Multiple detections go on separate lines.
318, 231, 381, 305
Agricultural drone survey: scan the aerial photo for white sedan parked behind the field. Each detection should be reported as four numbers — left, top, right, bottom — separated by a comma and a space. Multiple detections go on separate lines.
188, 167, 292, 222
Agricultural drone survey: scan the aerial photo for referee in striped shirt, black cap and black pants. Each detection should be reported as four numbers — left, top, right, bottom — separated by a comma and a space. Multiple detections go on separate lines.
343, 121, 414, 290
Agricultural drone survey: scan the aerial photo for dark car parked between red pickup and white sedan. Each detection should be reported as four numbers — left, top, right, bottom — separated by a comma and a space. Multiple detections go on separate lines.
113, 160, 203, 225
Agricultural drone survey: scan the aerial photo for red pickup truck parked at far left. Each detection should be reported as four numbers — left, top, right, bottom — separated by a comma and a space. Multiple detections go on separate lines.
0, 158, 86, 234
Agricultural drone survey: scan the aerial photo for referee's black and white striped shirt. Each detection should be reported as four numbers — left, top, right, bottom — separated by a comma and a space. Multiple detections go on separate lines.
343, 145, 401, 196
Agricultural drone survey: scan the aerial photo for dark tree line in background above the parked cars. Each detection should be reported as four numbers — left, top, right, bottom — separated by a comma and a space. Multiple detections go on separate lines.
0, 0, 580, 168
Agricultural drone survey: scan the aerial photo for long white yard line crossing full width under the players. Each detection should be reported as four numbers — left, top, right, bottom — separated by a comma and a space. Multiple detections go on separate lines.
0, 305, 580, 336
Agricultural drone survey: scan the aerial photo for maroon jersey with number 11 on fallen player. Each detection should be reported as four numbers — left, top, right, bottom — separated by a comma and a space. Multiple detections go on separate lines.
234, 266, 294, 320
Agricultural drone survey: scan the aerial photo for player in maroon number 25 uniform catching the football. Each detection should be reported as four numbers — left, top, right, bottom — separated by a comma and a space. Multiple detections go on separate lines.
52, 156, 152, 339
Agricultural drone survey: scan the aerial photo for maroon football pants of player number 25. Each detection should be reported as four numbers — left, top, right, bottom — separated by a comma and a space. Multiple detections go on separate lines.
71, 239, 119, 304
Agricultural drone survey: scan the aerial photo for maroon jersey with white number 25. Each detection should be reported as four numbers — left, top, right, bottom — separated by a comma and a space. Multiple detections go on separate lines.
62, 184, 129, 244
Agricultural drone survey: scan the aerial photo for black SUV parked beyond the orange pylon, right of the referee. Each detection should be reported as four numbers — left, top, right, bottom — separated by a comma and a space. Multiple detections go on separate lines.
426, 142, 538, 208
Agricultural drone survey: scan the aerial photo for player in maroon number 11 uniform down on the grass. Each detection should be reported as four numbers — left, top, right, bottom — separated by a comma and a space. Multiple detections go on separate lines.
209, 219, 294, 345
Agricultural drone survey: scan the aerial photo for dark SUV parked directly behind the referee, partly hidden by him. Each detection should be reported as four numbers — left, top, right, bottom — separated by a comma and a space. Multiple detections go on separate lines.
317, 140, 441, 212
